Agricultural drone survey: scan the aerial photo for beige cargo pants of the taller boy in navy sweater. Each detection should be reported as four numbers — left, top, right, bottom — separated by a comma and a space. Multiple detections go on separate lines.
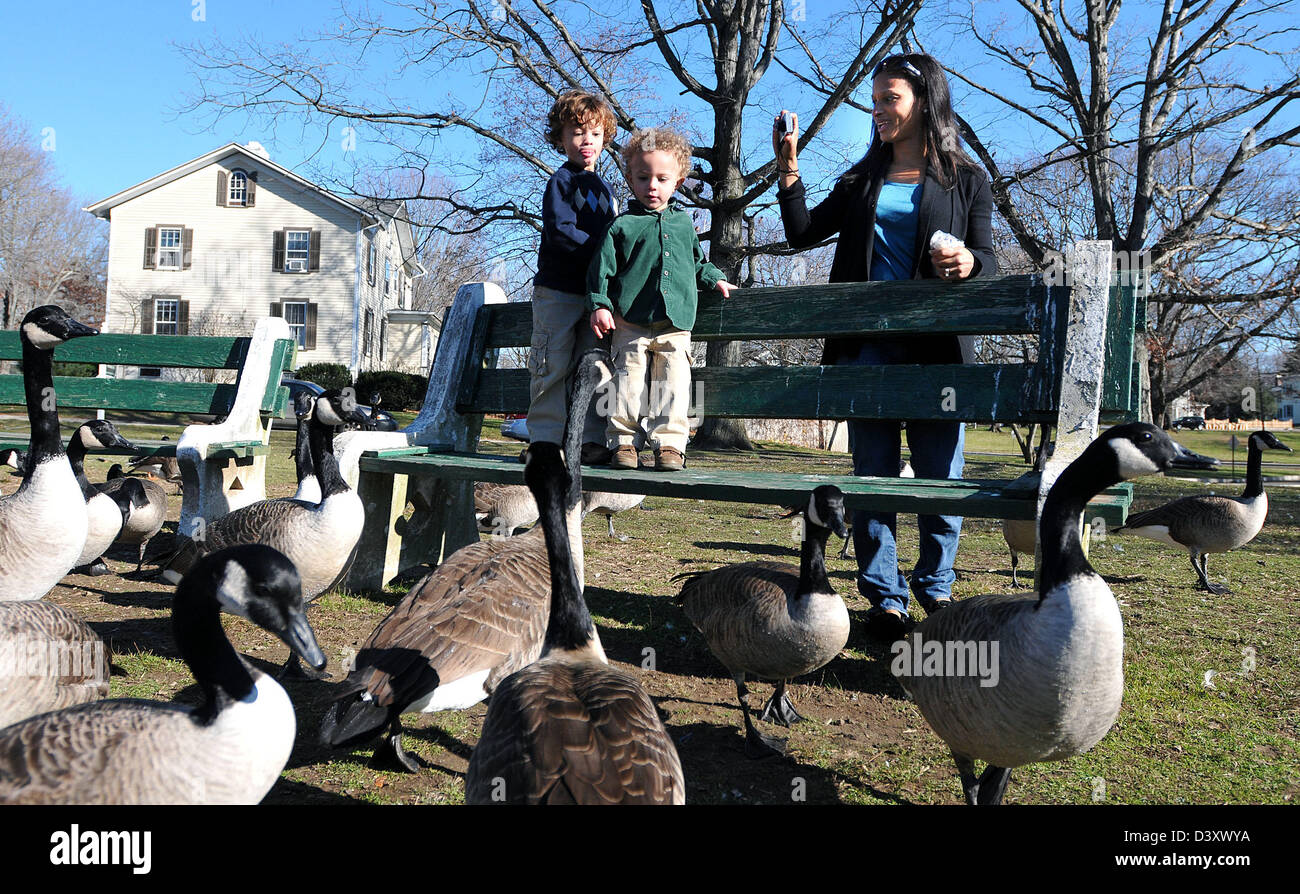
528, 286, 605, 444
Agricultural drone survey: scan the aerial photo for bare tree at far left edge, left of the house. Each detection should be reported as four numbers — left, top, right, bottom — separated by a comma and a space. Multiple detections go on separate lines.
0, 105, 108, 329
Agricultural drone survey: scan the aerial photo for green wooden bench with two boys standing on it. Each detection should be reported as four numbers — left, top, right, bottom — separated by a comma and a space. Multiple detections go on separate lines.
338, 243, 1141, 590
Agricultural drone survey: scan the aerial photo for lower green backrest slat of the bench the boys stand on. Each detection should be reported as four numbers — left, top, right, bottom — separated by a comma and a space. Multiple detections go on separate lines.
458, 364, 1054, 422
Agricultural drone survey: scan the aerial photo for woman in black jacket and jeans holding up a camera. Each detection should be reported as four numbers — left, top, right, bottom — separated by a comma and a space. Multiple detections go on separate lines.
772, 53, 997, 639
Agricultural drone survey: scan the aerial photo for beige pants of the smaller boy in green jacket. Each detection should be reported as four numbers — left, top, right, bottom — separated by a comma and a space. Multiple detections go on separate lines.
597, 317, 690, 453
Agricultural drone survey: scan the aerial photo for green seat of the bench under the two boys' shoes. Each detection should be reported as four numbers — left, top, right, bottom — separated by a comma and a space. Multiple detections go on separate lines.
360, 453, 1131, 525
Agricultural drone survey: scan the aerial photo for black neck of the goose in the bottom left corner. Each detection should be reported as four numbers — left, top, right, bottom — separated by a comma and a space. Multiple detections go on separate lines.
172, 565, 254, 725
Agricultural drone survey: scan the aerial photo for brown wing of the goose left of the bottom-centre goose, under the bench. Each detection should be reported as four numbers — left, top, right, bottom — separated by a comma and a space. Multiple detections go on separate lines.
348, 529, 551, 706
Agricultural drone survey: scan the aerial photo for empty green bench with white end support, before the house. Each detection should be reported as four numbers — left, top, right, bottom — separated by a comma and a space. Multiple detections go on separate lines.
0, 318, 296, 533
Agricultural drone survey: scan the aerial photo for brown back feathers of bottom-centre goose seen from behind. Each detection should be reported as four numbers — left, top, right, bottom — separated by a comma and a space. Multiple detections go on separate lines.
467, 659, 685, 804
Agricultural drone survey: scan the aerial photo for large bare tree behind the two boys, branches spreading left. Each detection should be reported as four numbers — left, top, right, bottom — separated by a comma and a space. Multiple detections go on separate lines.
178, 0, 920, 447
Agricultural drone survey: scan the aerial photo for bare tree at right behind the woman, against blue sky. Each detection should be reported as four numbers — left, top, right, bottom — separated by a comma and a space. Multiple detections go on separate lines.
925, 0, 1300, 417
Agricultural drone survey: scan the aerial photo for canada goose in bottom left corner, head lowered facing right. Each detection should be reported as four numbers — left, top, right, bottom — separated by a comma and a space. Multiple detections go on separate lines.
0, 544, 325, 804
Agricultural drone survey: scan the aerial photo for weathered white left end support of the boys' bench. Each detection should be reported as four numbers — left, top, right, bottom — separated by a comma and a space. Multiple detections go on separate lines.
335, 282, 506, 591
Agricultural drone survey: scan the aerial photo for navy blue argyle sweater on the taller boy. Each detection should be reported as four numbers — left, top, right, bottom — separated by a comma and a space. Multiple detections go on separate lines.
533, 161, 615, 295
